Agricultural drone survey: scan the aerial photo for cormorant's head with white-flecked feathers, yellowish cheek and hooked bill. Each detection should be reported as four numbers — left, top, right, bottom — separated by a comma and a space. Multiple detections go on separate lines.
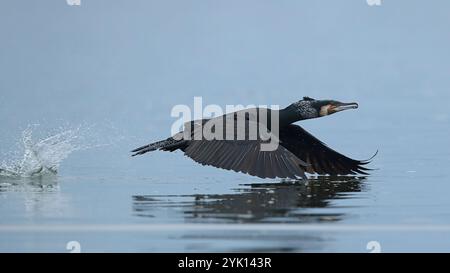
293, 97, 358, 119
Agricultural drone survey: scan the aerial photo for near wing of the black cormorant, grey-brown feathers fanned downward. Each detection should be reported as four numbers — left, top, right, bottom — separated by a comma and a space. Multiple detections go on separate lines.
184, 117, 306, 178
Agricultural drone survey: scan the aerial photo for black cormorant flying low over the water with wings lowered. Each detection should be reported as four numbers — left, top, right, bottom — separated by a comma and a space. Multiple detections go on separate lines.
132, 97, 373, 179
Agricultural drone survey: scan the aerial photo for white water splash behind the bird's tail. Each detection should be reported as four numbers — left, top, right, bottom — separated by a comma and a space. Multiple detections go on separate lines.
0, 126, 87, 177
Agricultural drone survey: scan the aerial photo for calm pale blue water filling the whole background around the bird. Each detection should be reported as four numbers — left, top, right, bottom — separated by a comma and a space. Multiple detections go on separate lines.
0, 0, 450, 252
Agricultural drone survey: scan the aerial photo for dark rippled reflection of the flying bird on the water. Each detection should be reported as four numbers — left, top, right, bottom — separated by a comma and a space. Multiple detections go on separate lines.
133, 177, 364, 223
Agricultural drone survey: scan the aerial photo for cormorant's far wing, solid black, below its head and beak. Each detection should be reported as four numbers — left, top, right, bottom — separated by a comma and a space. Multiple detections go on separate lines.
280, 124, 370, 175
